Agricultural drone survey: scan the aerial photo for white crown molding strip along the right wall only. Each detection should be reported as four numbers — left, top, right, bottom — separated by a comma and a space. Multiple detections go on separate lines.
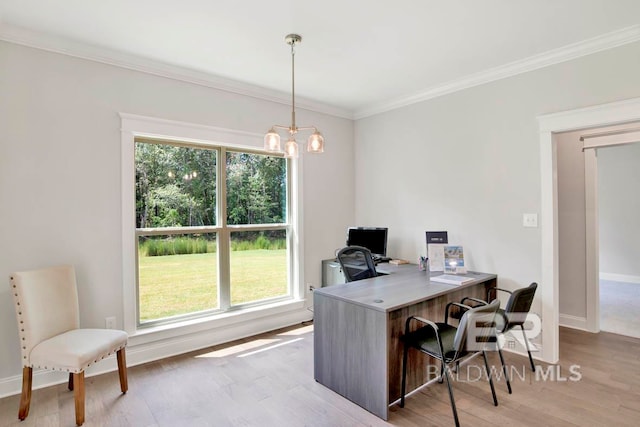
354, 25, 640, 120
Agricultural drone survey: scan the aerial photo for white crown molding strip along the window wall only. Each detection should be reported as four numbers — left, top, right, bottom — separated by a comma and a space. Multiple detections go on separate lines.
0, 21, 353, 120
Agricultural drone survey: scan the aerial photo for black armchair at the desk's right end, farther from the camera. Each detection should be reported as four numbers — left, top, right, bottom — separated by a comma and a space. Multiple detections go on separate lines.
461, 282, 538, 372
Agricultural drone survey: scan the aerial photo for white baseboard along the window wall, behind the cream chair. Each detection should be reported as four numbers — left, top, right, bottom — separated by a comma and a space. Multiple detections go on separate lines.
0, 308, 313, 402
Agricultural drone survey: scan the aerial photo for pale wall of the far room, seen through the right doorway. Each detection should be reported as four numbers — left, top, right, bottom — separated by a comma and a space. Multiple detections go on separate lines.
598, 143, 640, 281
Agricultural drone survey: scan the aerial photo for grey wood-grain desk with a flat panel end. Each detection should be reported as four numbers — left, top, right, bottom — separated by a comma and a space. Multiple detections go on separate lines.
313, 264, 497, 420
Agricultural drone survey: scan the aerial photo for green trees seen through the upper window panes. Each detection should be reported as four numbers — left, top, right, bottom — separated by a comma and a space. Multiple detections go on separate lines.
135, 142, 287, 232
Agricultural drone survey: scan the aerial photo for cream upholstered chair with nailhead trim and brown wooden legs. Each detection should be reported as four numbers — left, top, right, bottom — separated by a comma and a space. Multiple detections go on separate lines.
11, 265, 128, 425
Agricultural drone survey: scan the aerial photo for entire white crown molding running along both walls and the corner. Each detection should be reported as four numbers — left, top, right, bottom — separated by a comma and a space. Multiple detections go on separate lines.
0, 22, 640, 120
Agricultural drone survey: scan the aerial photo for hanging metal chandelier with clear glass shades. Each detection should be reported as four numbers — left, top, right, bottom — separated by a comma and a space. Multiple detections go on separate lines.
264, 34, 324, 158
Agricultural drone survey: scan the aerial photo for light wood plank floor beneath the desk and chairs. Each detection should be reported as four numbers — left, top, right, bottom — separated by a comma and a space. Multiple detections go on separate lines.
0, 325, 640, 427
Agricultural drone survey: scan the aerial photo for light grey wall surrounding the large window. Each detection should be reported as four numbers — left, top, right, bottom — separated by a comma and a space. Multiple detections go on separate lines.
0, 42, 354, 391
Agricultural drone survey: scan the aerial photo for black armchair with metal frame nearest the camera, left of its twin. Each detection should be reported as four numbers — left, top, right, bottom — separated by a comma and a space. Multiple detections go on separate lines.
400, 299, 500, 427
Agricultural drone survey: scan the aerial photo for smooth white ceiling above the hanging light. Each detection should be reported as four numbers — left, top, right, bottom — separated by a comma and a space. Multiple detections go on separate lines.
0, 0, 640, 118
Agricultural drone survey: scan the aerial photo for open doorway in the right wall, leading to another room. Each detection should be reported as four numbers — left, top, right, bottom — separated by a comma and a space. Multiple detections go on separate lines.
554, 123, 640, 332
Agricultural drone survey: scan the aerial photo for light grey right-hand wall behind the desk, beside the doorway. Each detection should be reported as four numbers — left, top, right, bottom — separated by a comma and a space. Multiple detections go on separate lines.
355, 43, 640, 324
